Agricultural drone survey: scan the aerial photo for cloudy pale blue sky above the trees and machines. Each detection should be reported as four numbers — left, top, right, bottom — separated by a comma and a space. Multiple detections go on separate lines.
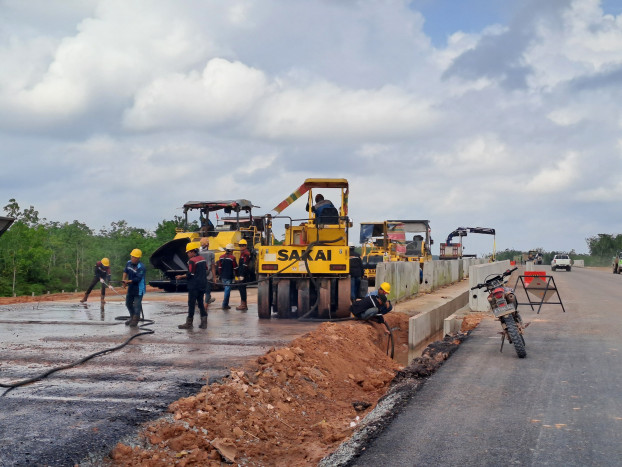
0, 0, 622, 254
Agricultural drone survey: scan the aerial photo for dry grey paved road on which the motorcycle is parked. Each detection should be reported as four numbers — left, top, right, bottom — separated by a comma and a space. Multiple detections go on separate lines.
353, 267, 622, 466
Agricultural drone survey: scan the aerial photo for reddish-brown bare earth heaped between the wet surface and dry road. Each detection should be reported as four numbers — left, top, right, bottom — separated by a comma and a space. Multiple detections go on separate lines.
0, 293, 484, 466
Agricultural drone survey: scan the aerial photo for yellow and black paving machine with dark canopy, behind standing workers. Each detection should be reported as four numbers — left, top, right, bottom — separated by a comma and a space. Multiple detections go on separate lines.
149, 199, 263, 292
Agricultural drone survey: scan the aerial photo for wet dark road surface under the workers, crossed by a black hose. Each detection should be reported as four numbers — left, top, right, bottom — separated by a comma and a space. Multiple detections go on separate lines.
0, 291, 318, 466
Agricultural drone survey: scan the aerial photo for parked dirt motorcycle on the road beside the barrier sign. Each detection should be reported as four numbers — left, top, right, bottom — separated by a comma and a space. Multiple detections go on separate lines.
471, 268, 529, 358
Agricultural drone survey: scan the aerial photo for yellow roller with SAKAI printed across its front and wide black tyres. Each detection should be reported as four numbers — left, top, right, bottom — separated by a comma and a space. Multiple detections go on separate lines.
257, 178, 351, 319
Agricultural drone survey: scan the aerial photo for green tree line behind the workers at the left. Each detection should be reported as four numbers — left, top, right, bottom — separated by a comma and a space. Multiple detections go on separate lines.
0, 199, 190, 297
